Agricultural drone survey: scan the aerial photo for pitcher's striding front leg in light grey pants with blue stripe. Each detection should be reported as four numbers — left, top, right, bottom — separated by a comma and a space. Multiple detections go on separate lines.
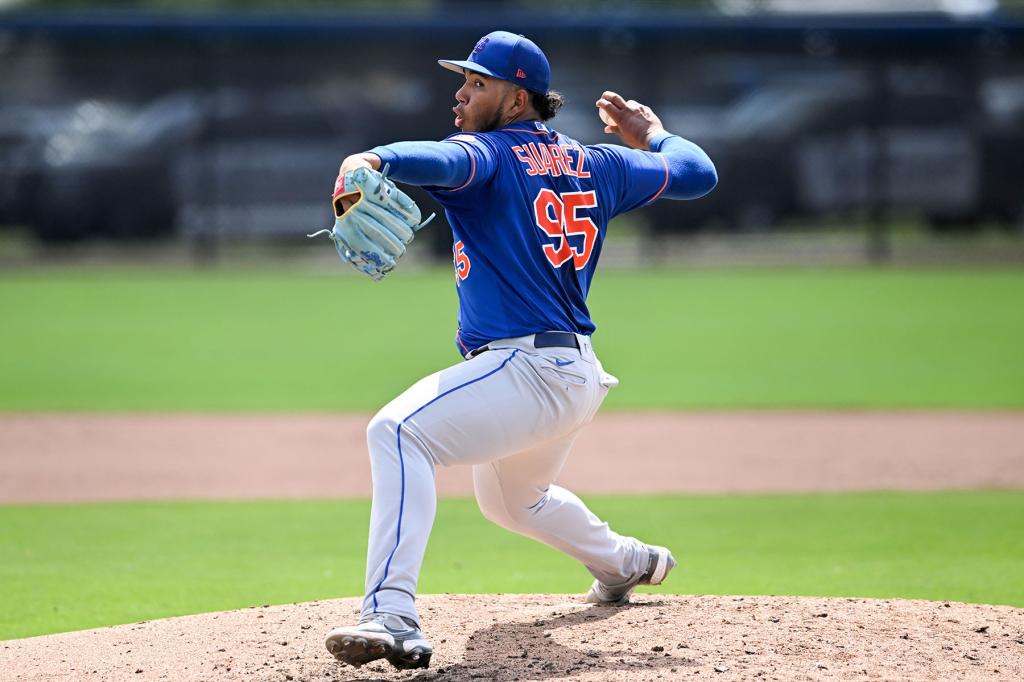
362, 350, 543, 623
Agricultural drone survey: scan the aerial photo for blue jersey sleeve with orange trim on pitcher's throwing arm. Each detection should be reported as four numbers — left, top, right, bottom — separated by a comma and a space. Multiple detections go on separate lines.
587, 144, 669, 218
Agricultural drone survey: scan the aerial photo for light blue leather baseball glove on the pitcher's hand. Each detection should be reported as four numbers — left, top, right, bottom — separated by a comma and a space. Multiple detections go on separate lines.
307, 166, 434, 282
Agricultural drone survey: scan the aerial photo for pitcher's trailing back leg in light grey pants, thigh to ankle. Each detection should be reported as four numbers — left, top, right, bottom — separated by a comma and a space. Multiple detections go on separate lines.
473, 434, 647, 584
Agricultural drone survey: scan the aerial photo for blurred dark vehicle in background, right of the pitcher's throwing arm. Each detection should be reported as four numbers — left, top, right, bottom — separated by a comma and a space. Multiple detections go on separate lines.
651, 66, 1024, 231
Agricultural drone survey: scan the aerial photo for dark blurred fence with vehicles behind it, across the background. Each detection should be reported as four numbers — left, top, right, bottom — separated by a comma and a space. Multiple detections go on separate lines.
0, 10, 1024, 259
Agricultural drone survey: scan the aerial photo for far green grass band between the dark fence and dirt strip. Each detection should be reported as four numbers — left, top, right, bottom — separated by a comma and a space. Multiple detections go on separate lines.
0, 268, 1024, 411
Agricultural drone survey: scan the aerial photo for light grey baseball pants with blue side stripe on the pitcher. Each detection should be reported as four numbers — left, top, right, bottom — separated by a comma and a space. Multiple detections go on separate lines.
362, 335, 648, 623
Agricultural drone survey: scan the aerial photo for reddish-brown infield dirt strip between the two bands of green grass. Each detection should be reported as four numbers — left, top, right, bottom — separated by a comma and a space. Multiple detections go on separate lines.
0, 412, 1024, 504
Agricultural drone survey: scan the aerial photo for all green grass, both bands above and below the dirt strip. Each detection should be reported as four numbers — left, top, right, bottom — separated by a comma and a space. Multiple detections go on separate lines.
0, 267, 1024, 639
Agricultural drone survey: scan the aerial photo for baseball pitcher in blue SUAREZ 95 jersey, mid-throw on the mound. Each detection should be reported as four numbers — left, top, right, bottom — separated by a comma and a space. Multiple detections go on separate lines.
315, 31, 718, 669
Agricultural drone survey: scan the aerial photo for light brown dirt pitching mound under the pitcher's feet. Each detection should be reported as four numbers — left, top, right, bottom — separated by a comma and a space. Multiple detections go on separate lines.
0, 595, 1024, 682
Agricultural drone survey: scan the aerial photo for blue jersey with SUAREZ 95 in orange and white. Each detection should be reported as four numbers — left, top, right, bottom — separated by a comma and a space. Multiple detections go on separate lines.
427, 121, 670, 354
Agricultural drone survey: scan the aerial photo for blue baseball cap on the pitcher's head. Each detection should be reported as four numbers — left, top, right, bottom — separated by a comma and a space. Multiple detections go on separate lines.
437, 31, 551, 94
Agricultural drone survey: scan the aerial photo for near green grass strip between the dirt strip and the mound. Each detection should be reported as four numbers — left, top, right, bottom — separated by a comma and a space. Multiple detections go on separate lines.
0, 492, 1024, 639
